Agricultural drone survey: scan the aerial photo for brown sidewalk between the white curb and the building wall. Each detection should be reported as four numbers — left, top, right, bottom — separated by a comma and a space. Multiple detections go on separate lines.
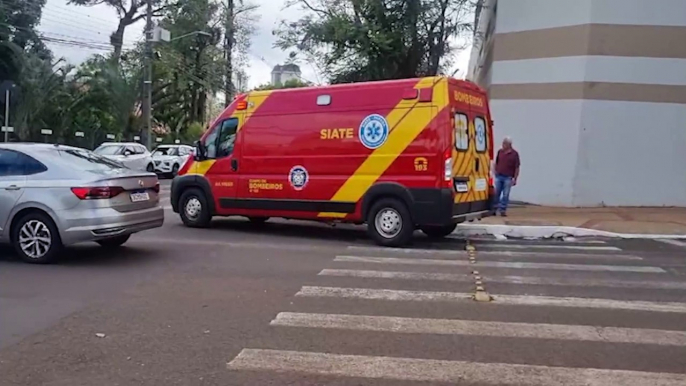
474, 206, 686, 235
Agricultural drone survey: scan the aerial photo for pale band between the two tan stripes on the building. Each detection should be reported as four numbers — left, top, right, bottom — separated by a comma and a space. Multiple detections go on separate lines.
491, 56, 686, 86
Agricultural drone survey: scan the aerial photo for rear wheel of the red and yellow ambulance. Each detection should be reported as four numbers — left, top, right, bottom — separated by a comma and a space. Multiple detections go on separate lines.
367, 198, 414, 247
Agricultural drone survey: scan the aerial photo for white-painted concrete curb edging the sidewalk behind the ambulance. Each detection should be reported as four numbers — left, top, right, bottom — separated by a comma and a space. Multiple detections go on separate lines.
454, 224, 686, 240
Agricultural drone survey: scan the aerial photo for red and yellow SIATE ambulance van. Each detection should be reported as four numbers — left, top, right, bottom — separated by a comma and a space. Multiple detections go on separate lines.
171, 77, 493, 246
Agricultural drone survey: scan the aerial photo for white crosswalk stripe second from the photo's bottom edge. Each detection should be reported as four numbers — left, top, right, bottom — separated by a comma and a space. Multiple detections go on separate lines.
270, 312, 686, 347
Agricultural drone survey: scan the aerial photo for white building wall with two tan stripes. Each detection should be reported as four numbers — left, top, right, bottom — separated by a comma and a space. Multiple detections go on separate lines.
468, 0, 686, 206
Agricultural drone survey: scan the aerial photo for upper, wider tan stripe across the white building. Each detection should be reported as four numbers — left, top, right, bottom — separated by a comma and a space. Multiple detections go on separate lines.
493, 24, 686, 61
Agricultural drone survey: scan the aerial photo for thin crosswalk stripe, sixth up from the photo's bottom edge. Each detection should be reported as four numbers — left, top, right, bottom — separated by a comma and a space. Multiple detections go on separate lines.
348, 245, 643, 260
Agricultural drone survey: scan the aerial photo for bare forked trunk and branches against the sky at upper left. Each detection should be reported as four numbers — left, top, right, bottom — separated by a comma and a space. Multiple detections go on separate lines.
69, 0, 173, 63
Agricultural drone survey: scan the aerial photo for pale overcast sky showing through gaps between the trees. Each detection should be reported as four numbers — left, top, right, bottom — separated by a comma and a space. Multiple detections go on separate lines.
39, 0, 470, 88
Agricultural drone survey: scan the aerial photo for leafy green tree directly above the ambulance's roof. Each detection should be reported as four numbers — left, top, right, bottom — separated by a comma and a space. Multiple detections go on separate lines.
275, 0, 476, 83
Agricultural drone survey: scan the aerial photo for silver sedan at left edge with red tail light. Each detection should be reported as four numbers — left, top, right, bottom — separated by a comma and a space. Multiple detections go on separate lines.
0, 143, 164, 263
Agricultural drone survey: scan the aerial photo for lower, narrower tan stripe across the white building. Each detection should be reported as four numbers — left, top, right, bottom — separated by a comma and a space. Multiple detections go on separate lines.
489, 82, 686, 104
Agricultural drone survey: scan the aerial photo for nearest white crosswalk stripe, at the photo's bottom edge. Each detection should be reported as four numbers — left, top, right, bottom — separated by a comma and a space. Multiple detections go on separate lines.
227, 349, 686, 386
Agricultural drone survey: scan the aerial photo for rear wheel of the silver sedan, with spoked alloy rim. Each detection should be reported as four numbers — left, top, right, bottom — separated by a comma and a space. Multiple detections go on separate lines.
12, 212, 62, 264
